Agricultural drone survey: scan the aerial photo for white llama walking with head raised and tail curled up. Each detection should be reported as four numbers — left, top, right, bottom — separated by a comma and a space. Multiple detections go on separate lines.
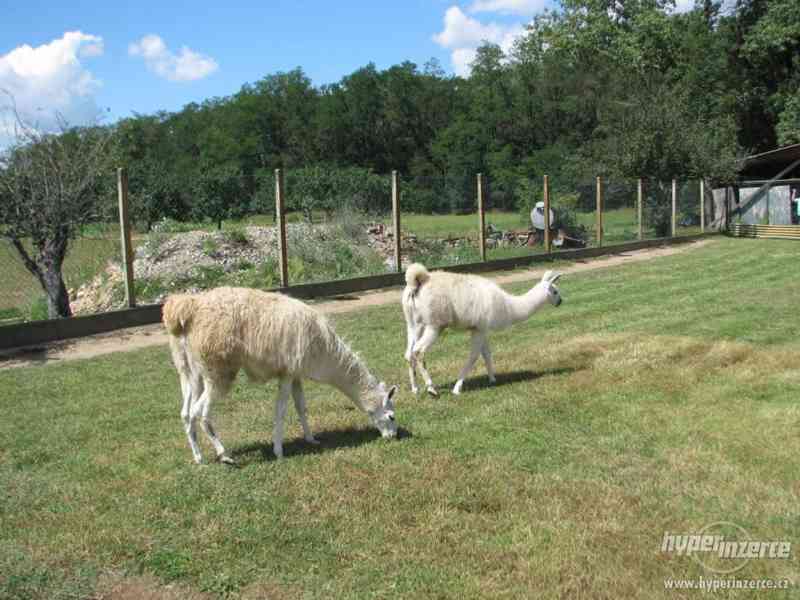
403, 263, 561, 396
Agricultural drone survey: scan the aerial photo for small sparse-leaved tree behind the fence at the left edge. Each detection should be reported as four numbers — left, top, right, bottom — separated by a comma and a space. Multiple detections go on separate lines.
0, 104, 109, 318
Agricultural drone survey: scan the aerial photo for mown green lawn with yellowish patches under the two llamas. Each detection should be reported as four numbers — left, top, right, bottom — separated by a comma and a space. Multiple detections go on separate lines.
0, 238, 800, 599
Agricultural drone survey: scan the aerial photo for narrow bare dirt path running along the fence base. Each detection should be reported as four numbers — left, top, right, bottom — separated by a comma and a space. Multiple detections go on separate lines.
0, 240, 712, 370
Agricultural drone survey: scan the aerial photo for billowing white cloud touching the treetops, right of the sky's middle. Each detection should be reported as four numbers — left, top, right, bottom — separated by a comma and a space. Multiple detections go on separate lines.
433, 6, 525, 77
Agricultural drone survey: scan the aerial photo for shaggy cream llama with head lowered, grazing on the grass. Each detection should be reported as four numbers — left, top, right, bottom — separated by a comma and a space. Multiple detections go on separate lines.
164, 287, 397, 463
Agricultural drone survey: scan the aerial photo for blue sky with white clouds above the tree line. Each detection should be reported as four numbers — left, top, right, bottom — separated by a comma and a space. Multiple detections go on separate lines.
0, 0, 546, 137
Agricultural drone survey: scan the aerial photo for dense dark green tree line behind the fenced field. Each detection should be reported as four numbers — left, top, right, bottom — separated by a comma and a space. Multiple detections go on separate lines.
104, 0, 800, 224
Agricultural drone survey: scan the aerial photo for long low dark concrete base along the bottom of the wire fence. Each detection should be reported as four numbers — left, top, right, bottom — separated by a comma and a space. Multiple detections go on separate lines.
0, 233, 718, 350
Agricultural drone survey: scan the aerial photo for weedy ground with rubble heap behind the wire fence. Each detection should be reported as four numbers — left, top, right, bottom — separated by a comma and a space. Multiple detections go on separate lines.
0, 169, 710, 337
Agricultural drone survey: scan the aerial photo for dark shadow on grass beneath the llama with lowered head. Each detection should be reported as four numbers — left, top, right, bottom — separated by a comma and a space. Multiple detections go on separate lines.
230, 427, 412, 467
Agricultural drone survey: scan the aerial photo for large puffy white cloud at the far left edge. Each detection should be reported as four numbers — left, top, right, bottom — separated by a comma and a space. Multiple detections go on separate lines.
0, 31, 103, 148
